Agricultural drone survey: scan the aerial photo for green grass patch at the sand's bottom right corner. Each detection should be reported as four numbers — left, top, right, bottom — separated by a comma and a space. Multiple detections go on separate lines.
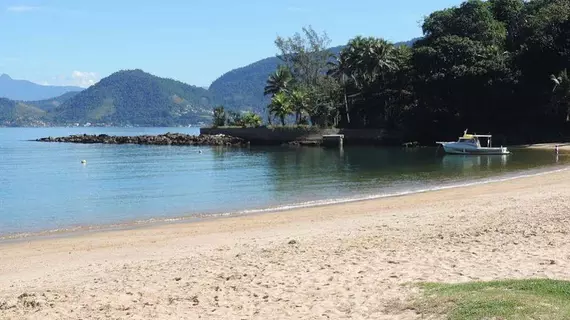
411, 279, 570, 320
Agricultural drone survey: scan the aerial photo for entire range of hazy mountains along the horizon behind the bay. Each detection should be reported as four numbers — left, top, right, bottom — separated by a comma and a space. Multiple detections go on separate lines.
0, 39, 416, 126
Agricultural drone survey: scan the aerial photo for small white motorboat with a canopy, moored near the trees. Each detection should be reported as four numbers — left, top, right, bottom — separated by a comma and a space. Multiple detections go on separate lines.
437, 130, 510, 155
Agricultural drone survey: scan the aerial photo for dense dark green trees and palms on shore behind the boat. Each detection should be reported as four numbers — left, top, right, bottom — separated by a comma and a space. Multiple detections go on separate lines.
268, 0, 570, 143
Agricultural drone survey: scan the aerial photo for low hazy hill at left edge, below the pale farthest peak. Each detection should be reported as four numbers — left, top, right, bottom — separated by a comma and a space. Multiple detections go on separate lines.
0, 98, 46, 127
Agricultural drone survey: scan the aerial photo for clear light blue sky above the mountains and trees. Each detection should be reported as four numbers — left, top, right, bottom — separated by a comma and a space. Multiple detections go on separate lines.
0, 0, 461, 87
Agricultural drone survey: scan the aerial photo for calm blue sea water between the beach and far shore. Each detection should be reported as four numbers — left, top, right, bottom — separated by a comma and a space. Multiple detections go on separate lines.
0, 128, 570, 235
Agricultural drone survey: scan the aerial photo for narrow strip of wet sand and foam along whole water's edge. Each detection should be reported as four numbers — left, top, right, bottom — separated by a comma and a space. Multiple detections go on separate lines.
0, 165, 570, 245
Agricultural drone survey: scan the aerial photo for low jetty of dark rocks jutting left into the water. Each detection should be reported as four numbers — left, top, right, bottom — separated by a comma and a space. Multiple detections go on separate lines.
35, 133, 249, 147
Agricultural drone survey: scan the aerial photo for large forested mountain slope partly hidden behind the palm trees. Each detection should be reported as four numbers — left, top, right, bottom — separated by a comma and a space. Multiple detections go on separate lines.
209, 38, 419, 114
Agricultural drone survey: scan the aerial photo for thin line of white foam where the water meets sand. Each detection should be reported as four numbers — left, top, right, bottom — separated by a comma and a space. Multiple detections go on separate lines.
207, 167, 570, 217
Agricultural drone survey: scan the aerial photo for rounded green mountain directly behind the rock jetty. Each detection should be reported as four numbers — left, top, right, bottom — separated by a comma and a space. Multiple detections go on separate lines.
48, 69, 212, 126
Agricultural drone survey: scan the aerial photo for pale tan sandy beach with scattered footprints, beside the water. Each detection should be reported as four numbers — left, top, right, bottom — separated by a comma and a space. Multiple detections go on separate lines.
0, 171, 570, 319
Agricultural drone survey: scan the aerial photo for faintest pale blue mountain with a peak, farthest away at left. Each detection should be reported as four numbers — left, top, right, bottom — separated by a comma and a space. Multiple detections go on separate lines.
0, 74, 83, 100
